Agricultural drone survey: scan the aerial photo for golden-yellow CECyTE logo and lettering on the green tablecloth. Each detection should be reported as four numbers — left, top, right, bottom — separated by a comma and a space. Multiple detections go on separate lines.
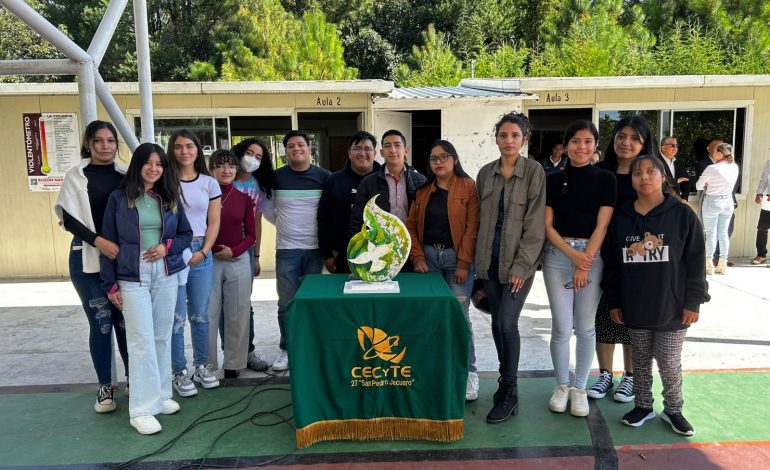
350, 326, 414, 387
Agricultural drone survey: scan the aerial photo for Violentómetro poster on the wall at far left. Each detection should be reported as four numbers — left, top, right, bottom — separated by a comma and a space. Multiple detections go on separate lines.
23, 113, 80, 191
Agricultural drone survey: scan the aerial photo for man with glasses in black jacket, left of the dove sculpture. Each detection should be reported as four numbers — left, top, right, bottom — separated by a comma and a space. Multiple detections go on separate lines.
318, 131, 380, 273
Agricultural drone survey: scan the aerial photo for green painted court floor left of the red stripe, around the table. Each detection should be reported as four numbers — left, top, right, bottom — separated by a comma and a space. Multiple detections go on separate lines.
0, 379, 591, 465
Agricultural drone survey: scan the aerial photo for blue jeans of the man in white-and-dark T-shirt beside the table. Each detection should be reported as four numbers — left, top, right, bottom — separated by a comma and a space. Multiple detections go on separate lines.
275, 248, 324, 351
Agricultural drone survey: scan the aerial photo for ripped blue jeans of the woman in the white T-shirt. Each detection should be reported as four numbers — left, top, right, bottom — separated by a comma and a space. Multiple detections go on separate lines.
171, 237, 213, 374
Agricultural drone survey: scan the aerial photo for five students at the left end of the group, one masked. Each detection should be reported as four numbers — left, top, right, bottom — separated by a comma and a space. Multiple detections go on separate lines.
55, 121, 280, 434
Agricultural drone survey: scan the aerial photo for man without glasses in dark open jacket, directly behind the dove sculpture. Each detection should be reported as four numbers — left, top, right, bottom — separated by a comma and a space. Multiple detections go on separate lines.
348, 129, 427, 272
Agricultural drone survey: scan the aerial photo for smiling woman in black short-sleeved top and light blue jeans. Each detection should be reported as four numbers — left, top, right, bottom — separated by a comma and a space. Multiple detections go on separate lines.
543, 120, 616, 416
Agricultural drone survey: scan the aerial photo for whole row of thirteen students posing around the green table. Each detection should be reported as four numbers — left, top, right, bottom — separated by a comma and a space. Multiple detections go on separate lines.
56, 113, 708, 435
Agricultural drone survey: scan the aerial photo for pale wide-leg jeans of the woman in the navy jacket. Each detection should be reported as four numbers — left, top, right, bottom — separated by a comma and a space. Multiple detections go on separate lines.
118, 255, 179, 418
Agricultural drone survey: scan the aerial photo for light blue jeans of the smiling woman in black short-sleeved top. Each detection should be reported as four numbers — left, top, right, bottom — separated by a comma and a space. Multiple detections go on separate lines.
543, 240, 604, 389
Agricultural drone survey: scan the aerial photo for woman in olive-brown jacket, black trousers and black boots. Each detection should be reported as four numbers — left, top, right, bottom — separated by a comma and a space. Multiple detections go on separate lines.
475, 112, 545, 423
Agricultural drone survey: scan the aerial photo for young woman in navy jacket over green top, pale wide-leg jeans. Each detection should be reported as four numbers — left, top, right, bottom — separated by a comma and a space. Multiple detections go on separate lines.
100, 143, 193, 434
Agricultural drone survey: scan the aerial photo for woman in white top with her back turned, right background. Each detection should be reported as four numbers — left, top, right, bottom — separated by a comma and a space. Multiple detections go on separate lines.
695, 144, 738, 274
